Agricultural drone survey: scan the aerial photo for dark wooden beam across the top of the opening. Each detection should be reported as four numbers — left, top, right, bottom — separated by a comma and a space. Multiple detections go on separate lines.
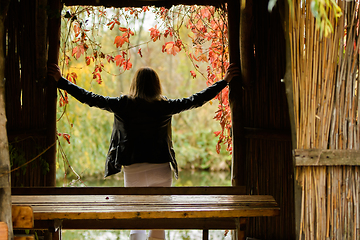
63, 0, 227, 8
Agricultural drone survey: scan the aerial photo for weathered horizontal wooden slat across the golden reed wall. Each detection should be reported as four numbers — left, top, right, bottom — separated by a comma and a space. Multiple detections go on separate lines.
293, 149, 360, 167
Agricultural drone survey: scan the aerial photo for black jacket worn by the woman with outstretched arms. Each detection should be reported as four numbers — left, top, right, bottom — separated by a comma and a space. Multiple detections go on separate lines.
58, 78, 227, 177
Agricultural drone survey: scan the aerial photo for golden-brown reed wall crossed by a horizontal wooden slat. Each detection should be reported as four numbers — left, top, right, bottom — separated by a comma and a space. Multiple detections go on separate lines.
289, 0, 360, 239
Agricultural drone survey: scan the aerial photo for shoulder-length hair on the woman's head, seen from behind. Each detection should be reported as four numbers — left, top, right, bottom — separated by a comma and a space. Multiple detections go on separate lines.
129, 67, 163, 102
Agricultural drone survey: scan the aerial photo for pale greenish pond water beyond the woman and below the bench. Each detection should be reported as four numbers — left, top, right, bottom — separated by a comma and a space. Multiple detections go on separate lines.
57, 171, 231, 240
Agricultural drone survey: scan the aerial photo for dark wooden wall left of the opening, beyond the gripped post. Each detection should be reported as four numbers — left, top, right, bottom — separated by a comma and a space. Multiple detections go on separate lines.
5, 0, 52, 186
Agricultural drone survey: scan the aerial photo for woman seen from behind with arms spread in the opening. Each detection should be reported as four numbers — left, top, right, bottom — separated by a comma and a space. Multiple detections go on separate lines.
49, 65, 240, 240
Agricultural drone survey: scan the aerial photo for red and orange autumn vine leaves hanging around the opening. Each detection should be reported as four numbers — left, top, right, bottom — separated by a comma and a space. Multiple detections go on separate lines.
60, 5, 232, 153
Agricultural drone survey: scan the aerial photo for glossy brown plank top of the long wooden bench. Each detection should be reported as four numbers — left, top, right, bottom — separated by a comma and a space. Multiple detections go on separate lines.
12, 195, 279, 220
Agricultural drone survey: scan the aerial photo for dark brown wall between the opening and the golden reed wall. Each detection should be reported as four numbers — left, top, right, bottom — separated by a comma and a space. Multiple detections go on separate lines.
243, 0, 295, 240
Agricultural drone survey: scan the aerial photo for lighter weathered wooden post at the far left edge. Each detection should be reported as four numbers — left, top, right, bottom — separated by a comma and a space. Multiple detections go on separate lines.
0, 0, 13, 239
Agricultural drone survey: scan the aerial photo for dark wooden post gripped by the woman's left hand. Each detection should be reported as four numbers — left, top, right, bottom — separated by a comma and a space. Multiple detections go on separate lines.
46, 0, 62, 186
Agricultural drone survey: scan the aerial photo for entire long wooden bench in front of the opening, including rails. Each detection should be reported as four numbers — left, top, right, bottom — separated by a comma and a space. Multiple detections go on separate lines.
12, 187, 280, 239
